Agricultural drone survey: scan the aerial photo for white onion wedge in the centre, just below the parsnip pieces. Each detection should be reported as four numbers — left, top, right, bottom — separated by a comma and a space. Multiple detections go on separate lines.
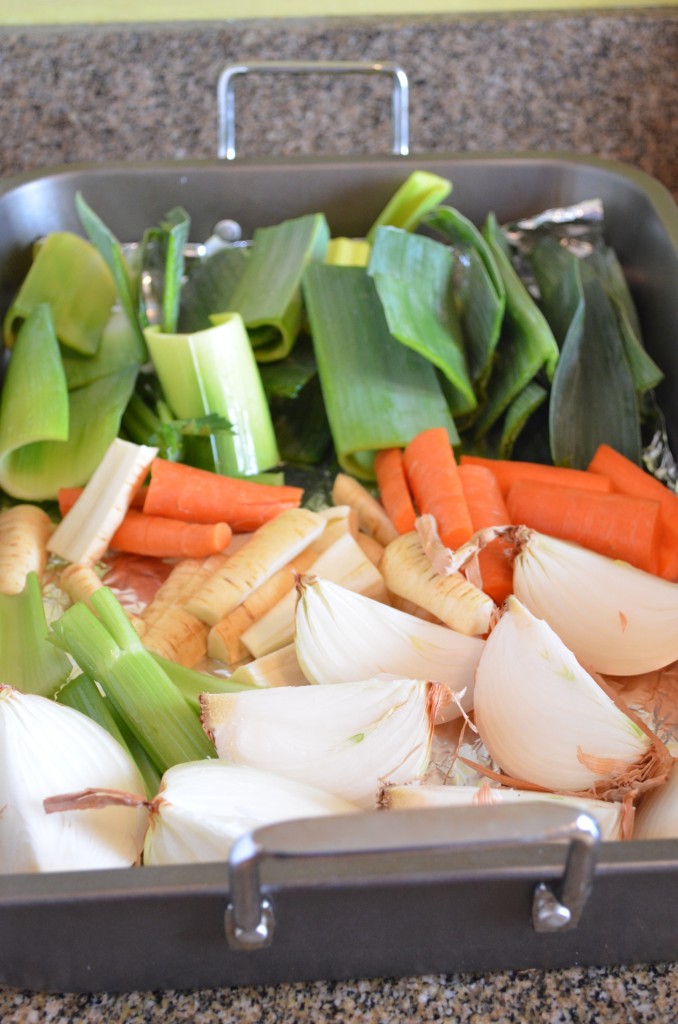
295, 575, 484, 722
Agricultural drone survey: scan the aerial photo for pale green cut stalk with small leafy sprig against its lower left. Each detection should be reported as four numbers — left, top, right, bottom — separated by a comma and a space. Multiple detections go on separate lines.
144, 313, 280, 476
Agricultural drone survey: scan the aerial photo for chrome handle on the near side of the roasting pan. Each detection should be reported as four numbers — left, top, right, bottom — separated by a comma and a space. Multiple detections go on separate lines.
224, 802, 600, 949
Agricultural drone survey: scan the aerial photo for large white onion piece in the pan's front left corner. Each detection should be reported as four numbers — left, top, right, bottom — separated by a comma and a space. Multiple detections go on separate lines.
0, 686, 147, 873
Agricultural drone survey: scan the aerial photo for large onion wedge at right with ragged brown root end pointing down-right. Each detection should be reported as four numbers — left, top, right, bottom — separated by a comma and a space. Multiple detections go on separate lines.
474, 596, 668, 798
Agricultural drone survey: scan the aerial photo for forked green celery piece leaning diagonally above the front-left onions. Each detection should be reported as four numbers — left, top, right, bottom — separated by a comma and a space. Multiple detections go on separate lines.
52, 587, 214, 773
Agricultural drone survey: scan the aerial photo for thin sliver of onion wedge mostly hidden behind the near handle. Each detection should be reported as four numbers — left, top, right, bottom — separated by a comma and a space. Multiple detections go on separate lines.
380, 782, 627, 840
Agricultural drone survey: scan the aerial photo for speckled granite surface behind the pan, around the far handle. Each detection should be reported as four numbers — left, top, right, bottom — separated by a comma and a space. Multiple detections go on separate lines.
0, 6, 678, 198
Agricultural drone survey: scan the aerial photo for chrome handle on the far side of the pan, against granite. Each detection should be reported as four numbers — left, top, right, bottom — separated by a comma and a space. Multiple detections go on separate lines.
217, 60, 410, 160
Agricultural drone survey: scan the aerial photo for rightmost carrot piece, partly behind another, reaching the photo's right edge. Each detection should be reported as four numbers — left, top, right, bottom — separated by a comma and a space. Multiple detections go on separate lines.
588, 444, 678, 582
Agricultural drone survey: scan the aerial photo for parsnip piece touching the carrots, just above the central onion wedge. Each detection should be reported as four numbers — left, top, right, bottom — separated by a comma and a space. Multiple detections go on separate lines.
380, 530, 497, 636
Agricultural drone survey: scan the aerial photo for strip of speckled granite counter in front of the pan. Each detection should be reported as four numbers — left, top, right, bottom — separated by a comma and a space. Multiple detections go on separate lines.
0, 965, 678, 1024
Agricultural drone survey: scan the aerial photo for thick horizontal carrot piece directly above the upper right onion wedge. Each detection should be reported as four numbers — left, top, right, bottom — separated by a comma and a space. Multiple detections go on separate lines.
506, 474, 661, 572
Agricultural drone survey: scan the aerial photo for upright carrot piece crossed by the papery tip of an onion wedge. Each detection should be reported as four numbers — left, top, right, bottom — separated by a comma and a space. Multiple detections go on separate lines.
459, 464, 513, 604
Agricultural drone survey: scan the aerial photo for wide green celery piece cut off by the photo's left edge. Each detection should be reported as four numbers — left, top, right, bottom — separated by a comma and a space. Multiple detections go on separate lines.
0, 572, 72, 697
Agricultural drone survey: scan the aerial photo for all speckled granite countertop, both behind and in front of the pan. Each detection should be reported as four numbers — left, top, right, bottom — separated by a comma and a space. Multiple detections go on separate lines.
0, 8, 678, 1024
